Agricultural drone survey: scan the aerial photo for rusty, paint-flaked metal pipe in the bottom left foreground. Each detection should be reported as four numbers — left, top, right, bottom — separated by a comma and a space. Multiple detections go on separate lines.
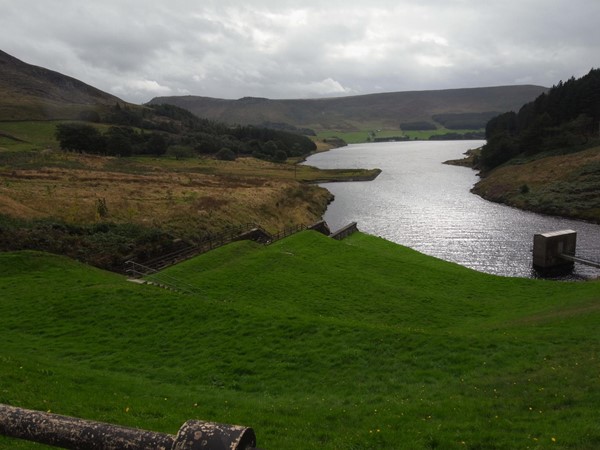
0, 404, 256, 450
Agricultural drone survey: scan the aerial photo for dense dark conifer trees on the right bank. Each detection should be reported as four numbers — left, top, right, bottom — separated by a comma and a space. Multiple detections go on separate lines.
479, 69, 600, 170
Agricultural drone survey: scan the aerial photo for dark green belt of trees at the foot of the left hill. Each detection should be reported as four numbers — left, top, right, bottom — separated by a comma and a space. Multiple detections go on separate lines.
56, 104, 316, 162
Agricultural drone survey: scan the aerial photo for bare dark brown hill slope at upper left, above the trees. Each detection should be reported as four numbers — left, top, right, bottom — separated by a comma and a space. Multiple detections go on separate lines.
0, 50, 125, 121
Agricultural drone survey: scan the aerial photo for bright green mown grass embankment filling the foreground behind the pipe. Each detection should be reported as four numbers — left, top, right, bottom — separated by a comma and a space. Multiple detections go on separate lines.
0, 232, 600, 449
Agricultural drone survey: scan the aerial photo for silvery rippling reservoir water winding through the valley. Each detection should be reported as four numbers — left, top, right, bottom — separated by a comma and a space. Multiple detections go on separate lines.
306, 141, 600, 279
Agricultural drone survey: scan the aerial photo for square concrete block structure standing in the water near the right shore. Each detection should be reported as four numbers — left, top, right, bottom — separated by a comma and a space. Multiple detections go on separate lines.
533, 230, 577, 270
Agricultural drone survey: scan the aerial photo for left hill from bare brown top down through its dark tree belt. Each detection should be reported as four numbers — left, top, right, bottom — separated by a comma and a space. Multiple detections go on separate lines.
0, 52, 324, 162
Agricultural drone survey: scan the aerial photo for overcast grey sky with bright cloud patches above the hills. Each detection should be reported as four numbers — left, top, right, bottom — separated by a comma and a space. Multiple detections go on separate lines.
0, 0, 600, 103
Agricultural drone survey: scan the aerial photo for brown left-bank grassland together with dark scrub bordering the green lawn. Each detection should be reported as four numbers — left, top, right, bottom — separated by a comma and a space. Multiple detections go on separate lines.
0, 134, 379, 271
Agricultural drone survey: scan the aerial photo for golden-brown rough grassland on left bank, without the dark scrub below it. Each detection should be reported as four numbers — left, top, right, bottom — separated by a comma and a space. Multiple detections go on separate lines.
0, 121, 376, 235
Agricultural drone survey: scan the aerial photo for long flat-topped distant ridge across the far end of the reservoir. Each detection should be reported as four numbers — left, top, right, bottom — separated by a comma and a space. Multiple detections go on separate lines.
150, 85, 546, 131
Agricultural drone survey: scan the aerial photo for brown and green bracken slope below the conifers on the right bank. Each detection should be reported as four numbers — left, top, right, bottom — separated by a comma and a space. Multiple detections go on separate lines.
473, 146, 600, 223
